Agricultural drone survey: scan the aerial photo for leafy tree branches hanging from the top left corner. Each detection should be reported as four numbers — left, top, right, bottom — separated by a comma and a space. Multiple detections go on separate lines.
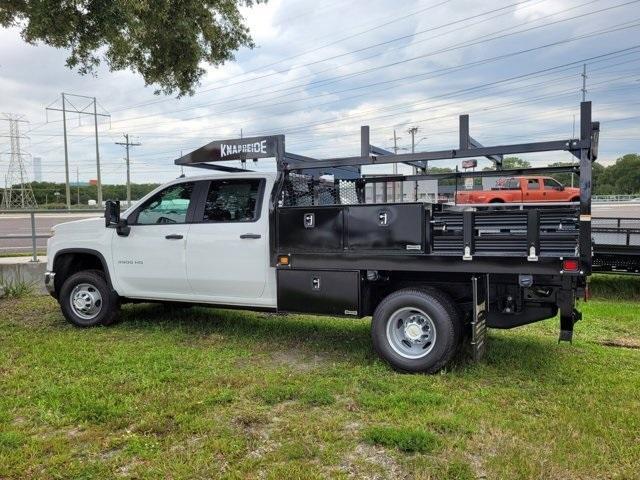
0, 0, 266, 96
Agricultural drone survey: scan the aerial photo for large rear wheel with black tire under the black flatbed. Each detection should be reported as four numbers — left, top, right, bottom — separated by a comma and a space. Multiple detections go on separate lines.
371, 288, 463, 373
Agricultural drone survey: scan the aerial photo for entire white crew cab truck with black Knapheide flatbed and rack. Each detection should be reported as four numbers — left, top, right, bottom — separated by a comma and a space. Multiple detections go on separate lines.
45, 102, 599, 372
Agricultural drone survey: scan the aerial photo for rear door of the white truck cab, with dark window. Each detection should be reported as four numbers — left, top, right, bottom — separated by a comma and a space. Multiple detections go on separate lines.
186, 177, 275, 306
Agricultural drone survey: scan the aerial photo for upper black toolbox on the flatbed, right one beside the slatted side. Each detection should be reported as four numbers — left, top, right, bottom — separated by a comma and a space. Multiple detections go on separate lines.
347, 203, 425, 252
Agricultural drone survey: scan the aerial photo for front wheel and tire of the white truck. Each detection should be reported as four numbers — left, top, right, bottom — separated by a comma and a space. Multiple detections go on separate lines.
58, 270, 120, 328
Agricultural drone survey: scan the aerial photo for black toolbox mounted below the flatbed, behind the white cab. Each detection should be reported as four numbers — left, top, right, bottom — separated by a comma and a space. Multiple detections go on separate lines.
278, 270, 360, 316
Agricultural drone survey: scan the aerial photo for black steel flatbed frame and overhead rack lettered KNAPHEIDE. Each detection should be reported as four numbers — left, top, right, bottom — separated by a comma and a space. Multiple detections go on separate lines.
175, 102, 600, 343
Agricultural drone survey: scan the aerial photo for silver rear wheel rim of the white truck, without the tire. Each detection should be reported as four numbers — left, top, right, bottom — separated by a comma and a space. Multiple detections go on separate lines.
387, 307, 436, 359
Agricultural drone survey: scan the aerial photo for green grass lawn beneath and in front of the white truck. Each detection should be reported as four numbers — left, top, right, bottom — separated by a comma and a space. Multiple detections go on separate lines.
0, 297, 640, 480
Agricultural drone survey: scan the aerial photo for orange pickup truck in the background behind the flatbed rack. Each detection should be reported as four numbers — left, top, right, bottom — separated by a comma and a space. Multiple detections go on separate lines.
456, 177, 580, 204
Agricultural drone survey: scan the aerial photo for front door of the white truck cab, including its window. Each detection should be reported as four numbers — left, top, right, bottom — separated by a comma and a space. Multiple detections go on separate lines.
111, 182, 195, 300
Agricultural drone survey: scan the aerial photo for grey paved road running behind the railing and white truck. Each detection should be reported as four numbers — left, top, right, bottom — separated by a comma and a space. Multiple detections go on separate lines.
0, 203, 640, 253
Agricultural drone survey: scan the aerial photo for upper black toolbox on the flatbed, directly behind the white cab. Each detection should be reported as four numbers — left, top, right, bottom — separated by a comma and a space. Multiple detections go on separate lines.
278, 206, 344, 254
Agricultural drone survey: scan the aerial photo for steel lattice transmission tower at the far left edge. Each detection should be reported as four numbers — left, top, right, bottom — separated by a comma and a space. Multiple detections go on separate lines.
2, 113, 38, 210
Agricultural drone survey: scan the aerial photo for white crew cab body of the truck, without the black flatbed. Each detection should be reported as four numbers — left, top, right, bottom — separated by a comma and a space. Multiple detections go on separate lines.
48, 173, 276, 308
